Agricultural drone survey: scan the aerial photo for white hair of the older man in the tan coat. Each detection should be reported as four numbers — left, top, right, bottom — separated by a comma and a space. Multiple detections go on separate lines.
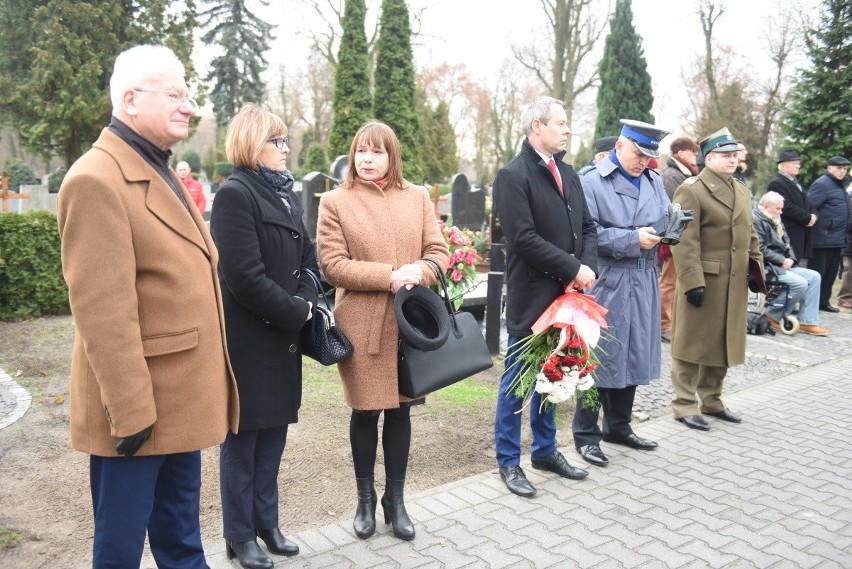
109, 44, 185, 110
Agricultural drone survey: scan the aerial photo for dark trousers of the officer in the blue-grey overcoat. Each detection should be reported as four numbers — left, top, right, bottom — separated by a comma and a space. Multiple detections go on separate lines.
571, 385, 636, 449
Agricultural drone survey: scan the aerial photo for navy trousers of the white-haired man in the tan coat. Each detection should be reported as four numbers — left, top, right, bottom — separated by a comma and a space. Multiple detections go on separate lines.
89, 451, 208, 569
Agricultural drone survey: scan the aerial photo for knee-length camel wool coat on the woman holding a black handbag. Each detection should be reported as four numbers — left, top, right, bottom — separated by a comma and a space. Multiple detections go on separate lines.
317, 180, 449, 411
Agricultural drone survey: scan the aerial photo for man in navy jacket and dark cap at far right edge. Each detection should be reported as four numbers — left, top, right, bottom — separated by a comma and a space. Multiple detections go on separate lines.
808, 156, 850, 312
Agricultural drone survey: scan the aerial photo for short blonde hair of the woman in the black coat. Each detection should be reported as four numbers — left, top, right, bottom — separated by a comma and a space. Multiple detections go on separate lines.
225, 103, 287, 169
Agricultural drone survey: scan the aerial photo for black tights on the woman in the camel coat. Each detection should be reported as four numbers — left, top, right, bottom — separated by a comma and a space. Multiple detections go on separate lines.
349, 407, 411, 480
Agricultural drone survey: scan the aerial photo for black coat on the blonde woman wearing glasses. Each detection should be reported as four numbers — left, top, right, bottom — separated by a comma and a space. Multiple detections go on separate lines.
210, 168, 317, 430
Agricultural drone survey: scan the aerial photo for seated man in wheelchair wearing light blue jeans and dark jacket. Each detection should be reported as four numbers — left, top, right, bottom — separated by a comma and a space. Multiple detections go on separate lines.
753, 192, 828, 336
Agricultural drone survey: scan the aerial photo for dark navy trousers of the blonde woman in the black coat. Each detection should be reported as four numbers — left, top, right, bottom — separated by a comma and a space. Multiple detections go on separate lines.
219, 425, 287, 543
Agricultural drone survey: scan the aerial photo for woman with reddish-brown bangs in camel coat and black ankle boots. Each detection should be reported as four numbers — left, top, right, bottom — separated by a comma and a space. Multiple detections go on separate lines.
317, 122, 449, 540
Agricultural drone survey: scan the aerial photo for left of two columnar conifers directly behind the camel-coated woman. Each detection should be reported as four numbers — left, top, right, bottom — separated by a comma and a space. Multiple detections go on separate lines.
328, 0, 373, 157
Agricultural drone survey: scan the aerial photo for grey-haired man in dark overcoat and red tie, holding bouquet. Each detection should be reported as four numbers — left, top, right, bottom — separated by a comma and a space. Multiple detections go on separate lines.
494, 97, 598, 497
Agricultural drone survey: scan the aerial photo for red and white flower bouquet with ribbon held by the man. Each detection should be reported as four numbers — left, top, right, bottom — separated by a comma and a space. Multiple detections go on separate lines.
503, 291, 607, 413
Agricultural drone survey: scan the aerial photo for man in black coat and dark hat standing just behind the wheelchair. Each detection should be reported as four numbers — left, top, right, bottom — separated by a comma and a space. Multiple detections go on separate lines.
766, 149, 816, 267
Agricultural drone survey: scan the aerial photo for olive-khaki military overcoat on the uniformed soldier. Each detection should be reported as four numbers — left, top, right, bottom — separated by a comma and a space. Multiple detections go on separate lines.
672, 168, 763, 367
